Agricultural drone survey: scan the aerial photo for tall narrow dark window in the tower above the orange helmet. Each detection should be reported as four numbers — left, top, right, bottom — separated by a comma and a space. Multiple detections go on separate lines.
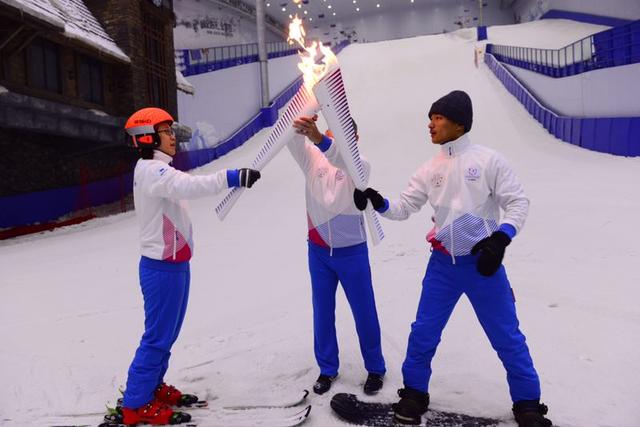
142, 9, 169, 109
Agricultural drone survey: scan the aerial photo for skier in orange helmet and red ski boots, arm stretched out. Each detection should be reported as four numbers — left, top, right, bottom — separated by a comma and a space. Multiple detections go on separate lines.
118, 108, 260, 424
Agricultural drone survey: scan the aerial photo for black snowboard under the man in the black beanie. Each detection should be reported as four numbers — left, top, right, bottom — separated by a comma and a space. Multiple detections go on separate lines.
331, 393, 504, 427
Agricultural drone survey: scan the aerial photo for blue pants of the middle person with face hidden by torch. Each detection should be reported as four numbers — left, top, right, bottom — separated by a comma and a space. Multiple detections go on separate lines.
309, 242, 386, 376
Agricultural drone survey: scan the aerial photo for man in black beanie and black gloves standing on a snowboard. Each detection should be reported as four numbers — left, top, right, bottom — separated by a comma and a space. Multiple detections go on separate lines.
354, 90, 552, 427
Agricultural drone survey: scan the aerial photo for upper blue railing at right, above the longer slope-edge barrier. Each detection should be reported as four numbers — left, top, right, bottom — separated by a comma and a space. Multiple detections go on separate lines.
486, 21, 640, 77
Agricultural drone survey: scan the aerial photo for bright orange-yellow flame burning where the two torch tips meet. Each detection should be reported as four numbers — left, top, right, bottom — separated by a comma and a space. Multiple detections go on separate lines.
287, 15, 338, 90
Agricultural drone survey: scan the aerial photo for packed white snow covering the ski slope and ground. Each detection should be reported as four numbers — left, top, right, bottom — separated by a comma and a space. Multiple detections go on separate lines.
0, 19, 640, 427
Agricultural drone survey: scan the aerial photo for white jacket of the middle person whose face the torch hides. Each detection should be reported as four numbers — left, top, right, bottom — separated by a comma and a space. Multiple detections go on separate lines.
287, 135, 370, 248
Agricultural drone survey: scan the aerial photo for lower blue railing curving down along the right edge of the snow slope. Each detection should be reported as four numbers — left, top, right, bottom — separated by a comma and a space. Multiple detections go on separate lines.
485, 53, 640, 157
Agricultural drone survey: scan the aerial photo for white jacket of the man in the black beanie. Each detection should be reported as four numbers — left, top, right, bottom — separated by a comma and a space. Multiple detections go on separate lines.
382, 134, 529, 261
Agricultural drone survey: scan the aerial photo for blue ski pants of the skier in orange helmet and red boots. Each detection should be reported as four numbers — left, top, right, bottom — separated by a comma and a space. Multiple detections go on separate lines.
123, 256, 190, 408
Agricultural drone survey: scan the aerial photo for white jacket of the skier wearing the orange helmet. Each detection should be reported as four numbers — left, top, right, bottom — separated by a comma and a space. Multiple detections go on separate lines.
133, 150, 229, 262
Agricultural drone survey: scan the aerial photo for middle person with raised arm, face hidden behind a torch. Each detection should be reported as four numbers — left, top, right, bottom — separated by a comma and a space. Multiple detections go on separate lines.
288, 116, 386, 394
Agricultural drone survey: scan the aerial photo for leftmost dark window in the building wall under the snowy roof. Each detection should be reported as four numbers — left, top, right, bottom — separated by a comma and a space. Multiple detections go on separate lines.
27, 39, 62, 93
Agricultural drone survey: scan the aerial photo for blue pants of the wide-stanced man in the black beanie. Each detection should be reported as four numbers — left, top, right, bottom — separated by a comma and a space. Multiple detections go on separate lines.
402, 251, 540, 402
